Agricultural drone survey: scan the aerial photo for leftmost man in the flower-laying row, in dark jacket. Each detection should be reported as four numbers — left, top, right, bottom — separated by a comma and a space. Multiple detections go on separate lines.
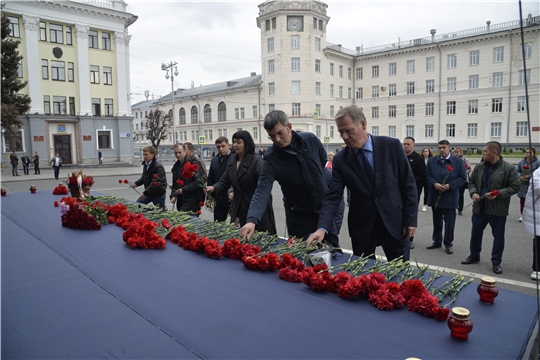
133, 145, 167, 207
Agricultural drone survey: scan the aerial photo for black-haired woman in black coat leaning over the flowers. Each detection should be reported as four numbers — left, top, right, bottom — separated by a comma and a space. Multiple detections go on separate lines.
206, 130, 276, 235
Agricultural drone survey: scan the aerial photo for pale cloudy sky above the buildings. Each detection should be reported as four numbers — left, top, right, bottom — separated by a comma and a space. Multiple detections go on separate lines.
125, 0, 540, 104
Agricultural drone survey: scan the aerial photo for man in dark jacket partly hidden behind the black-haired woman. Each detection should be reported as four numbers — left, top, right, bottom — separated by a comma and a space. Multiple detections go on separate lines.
207, 136, 232, 221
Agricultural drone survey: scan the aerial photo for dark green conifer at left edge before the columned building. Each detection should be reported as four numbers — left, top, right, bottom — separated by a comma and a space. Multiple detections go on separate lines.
0, 14, 31, 144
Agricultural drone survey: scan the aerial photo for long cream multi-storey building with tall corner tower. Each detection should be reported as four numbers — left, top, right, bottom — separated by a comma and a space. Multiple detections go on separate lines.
144, 0, 540, 159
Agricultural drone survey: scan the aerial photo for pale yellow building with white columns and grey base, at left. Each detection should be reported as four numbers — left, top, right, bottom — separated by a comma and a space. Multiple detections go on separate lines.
2, 0, 137, 166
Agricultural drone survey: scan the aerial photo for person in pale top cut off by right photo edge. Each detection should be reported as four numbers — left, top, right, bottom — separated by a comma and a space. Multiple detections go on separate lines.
523, 168, 540, 281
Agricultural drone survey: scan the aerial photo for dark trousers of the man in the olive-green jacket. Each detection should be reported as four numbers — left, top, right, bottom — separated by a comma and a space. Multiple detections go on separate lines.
471, 214, 506, 265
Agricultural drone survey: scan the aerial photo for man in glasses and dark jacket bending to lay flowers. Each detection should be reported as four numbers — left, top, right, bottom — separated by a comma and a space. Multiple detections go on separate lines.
240, 110, 338, 246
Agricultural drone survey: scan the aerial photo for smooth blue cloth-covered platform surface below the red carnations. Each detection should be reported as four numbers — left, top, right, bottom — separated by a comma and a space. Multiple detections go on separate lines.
1, 191, 537, 359
